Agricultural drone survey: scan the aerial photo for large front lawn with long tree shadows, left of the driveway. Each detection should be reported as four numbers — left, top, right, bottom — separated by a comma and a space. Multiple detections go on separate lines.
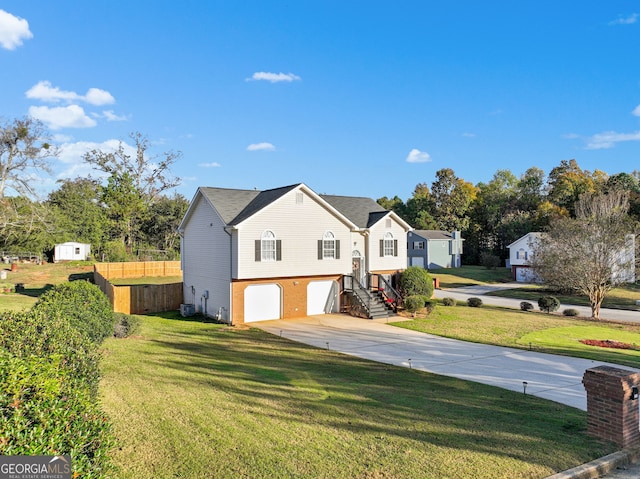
101, 316, 615, 479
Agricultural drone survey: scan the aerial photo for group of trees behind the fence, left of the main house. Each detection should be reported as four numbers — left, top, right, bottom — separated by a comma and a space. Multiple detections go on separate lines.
0, 117, 189, 261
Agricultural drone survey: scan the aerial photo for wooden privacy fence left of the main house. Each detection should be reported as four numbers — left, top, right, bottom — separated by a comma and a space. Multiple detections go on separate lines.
93, 261, 184, 314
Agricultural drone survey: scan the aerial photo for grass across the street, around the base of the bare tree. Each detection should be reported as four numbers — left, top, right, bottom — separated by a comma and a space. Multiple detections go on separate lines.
488, 284, 640, 311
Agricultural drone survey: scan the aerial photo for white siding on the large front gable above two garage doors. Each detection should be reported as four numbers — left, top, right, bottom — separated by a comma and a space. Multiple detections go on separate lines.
234, 190, 351, 279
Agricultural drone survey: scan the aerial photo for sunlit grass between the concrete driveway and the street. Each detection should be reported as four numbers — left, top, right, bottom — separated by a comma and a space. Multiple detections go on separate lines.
392, 304, 640, 368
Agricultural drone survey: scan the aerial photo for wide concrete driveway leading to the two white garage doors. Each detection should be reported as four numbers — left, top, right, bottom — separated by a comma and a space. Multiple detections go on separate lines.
251, 316, 640, 410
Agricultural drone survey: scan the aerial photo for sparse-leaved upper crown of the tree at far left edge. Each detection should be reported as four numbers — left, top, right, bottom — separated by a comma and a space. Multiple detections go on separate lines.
0, 117, 58, 200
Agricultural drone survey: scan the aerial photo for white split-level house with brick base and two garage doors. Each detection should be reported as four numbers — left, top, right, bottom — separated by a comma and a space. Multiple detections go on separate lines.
179, 183, 411, 324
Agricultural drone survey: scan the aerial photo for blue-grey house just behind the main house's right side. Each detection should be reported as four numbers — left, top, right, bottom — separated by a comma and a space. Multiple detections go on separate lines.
407, 230, 463, 269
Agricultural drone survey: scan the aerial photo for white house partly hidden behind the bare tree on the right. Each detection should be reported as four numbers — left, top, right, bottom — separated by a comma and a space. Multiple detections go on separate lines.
507, 232, 635, 283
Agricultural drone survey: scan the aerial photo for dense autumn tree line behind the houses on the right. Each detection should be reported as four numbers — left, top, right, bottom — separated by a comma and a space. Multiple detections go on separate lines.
377, 163, 640, 264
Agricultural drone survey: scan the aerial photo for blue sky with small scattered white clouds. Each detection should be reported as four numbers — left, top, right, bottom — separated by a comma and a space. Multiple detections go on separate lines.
0, 0, 640, 200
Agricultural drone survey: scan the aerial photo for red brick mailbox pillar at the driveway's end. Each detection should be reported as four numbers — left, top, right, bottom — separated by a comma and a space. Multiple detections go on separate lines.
582, 366, 640, 448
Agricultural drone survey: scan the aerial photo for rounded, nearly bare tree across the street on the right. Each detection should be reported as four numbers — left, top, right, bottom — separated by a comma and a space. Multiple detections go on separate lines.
530, 192, 635, 319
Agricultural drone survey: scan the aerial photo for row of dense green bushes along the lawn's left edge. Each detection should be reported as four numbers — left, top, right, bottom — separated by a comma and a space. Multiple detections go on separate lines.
0, 281, 114, 478
